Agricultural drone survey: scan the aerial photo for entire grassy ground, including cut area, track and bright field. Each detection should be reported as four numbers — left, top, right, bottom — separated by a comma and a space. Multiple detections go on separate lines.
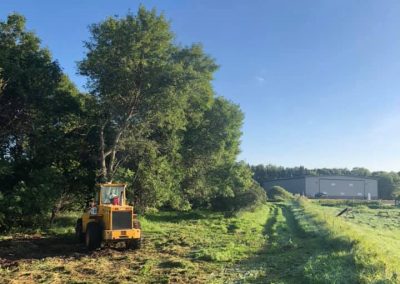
0, 199, 400, 283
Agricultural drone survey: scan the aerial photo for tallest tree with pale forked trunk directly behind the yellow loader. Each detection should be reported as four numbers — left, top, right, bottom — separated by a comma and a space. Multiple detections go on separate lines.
79, 7, 191, 181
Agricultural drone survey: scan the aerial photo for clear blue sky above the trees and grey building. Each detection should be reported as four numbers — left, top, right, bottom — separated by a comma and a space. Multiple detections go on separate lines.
0, 0, 400, 171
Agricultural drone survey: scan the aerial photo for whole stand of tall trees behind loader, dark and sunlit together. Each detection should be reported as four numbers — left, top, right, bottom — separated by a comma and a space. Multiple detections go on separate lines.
0, 7, 265, 230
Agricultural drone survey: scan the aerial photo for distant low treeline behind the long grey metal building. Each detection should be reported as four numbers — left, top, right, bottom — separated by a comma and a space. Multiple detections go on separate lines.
251, 165, 400, 199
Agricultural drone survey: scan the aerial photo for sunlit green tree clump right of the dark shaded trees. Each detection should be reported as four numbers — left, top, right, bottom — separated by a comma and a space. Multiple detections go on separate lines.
79, 7, 256, 211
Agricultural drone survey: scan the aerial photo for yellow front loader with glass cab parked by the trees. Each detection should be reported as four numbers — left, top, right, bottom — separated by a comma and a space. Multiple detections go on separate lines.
75, 184, 142, 250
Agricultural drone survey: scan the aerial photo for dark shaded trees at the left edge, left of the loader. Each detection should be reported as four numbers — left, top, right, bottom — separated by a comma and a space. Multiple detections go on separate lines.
0, 14, 94, 230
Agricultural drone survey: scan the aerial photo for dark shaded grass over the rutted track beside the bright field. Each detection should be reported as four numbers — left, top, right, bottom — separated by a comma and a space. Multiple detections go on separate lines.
234, 204, 358, 283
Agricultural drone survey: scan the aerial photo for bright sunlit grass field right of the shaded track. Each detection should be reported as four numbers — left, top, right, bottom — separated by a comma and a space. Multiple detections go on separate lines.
303, 201, 400, 283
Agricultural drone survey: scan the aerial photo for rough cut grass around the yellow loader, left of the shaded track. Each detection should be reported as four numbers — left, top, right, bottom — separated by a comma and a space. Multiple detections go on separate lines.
0, 205, 269, 283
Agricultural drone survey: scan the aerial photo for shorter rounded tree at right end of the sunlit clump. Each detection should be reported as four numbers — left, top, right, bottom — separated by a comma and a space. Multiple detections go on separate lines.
182, 97, 243, 203
